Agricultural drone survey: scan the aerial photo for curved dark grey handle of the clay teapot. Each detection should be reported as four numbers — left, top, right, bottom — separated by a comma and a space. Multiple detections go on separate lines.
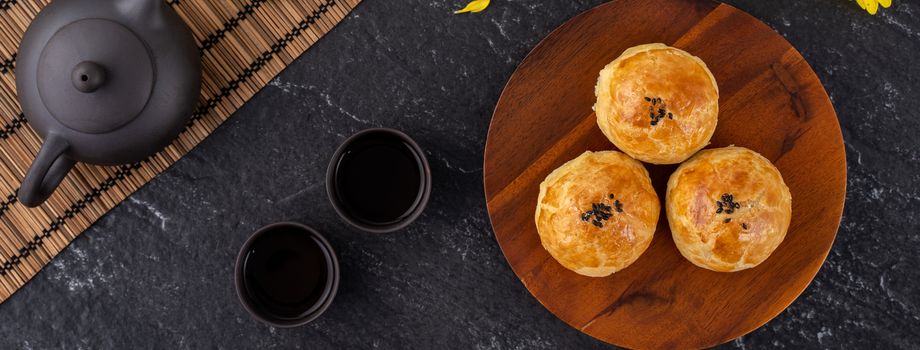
18, 134, 76, 208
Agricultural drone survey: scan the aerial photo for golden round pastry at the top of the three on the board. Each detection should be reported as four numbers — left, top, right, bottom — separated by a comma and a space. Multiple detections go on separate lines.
594, 44, 719, 164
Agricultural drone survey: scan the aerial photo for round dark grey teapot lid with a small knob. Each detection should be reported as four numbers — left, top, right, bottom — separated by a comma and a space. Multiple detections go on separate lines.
35, 18, 155, 134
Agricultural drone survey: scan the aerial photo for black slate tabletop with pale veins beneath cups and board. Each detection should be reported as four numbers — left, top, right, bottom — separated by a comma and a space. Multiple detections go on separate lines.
0, 0, 920, 349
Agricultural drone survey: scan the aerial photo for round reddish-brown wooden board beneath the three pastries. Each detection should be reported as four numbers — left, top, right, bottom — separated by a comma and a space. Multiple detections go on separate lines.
484, 0, 846, 348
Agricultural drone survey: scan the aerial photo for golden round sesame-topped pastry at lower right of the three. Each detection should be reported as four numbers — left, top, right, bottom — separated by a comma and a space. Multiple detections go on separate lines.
665, 147, 792, 272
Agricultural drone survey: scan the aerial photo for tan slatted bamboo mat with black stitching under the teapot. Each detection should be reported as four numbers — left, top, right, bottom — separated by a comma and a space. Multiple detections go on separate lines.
0, 0, 361, 302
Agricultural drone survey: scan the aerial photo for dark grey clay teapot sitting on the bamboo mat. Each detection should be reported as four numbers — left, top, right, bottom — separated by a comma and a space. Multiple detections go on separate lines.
16, 0, 201, 207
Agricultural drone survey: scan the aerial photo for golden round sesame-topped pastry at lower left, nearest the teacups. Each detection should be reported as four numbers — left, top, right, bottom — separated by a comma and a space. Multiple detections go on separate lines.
534, 151, 661, 277
